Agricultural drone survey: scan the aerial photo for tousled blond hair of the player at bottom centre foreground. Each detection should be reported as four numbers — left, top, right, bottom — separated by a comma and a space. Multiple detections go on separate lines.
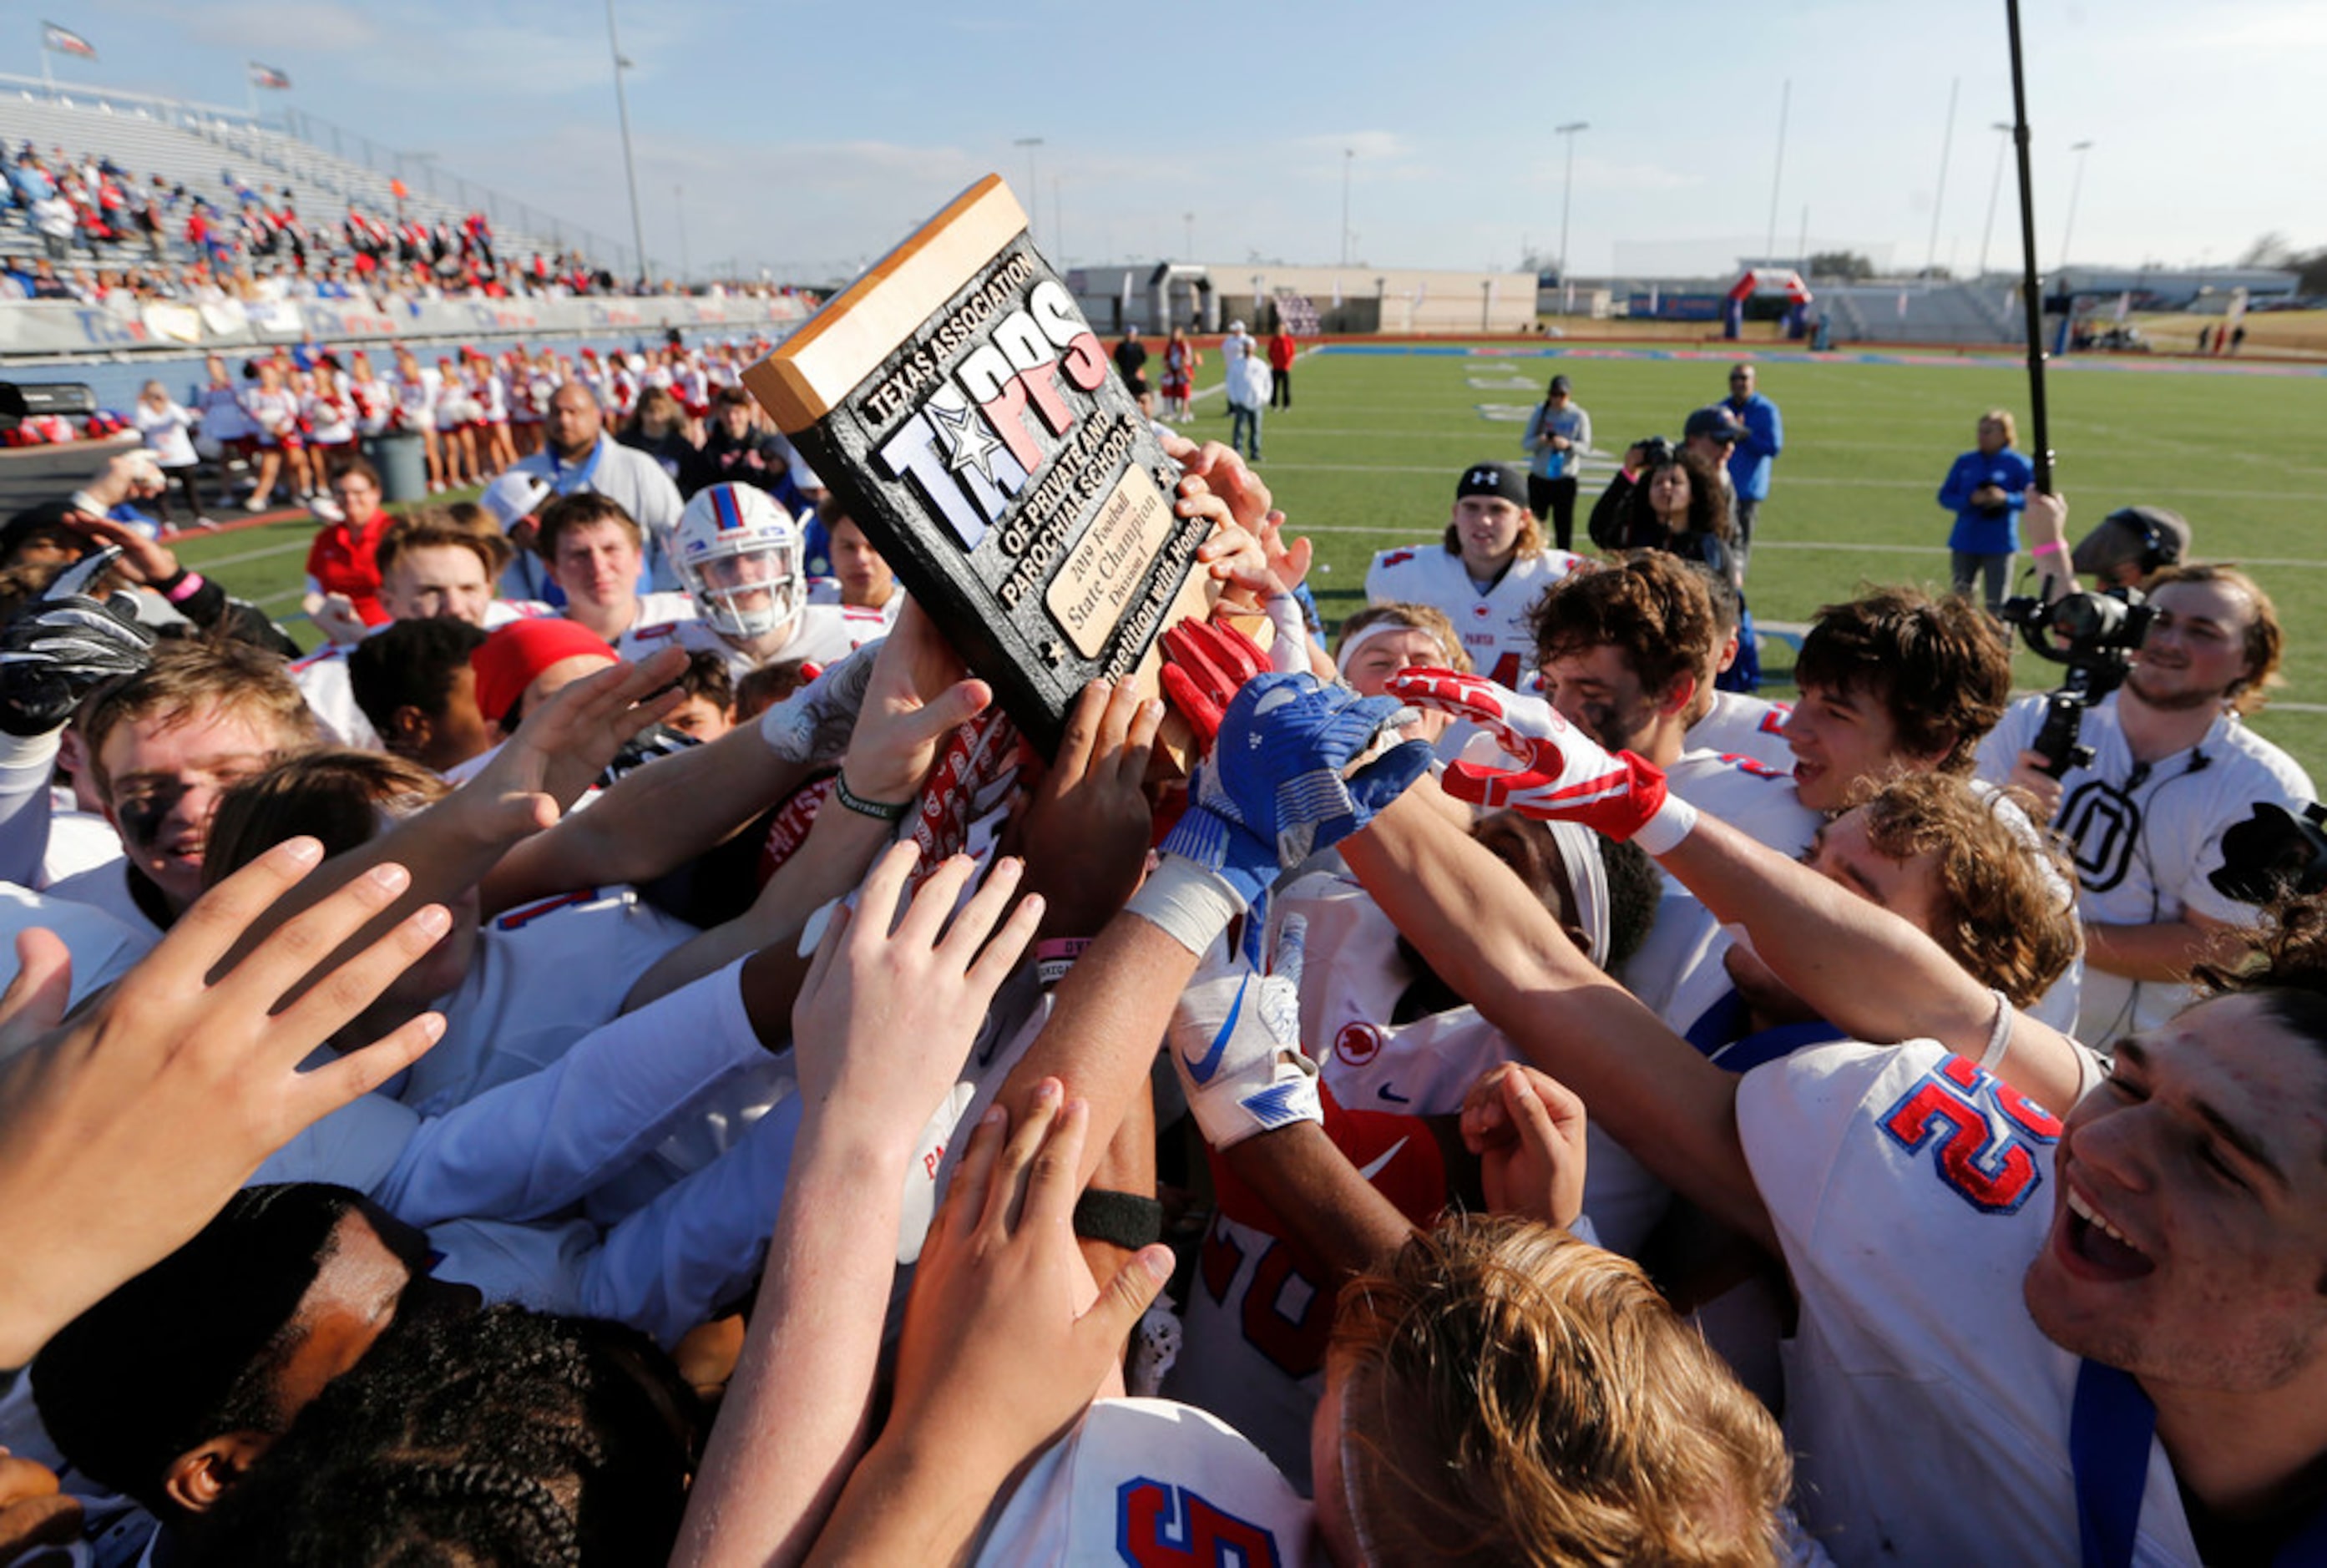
1333, 1216, 1792, 1565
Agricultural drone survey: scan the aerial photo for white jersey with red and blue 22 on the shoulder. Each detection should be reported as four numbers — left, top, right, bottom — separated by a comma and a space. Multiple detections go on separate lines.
1738, 1039, 2199, 1565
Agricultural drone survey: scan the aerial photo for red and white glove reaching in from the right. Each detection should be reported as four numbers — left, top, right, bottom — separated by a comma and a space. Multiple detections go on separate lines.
1387, 670, 1697, 854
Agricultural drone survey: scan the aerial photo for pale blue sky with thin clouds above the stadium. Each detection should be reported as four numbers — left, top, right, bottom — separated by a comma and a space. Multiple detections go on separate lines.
0, 0, 2327, 281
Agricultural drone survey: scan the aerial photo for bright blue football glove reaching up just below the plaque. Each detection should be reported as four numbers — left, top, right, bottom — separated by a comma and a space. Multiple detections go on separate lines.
1164, 672, 1431, 908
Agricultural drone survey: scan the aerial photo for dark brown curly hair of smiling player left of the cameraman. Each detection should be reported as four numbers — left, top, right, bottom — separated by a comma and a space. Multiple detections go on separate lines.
1794, 586, 2013, 775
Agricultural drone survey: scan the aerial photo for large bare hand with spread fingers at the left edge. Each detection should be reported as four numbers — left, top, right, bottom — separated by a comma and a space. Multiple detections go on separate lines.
0, 837, 452, 1366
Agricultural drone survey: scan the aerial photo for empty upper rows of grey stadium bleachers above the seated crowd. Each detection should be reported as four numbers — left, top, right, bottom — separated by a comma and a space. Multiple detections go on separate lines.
0, 77, 590, 263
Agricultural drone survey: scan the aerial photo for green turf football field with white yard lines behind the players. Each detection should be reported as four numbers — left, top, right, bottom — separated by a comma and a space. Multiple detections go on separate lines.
164, 349, 2327, 779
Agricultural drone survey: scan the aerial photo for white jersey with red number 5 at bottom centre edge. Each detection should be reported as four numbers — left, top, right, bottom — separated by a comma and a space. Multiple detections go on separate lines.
973, 1399, 1315, 1568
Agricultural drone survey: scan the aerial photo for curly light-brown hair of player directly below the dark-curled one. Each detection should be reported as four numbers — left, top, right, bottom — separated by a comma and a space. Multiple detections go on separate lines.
1857, 772, 2081, 1007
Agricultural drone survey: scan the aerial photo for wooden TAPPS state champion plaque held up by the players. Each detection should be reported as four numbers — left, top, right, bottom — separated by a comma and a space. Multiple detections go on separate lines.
742, 175, 1217, 756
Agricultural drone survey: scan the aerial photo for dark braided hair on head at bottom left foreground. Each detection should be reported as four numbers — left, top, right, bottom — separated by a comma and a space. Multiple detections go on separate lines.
189, 1305, 701, 1568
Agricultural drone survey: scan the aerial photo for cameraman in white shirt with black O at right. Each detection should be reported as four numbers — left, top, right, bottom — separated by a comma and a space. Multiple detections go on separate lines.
1978, 495, 2315, 1047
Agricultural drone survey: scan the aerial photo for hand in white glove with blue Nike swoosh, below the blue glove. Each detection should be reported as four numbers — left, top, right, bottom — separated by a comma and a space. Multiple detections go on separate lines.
1168, 914, 1324, 1149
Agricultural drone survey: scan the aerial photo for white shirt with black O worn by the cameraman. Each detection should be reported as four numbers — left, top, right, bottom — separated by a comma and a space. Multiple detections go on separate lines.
1980, 695, 2318, 1050
